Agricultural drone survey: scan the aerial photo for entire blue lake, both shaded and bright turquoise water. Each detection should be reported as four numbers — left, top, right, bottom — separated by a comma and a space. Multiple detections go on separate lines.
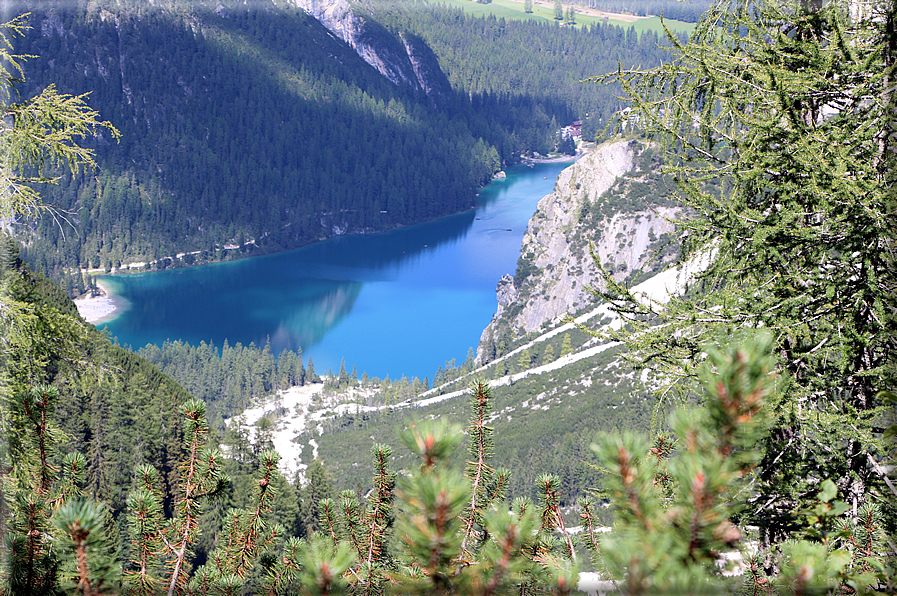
103, 164, 569, 379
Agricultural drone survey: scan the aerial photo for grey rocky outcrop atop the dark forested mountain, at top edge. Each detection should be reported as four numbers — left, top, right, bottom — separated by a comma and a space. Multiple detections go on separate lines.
293, 0, 450, 97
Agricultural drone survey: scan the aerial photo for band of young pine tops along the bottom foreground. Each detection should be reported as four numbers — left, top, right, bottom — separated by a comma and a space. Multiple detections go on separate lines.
0, 335, 894, 596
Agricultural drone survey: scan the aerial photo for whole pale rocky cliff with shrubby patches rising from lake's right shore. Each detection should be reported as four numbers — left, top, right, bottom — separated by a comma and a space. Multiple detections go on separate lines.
477, 141, 678, 362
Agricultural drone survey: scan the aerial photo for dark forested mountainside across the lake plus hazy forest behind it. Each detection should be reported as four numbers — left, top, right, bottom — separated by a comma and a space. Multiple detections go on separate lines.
8, 3, 672, 293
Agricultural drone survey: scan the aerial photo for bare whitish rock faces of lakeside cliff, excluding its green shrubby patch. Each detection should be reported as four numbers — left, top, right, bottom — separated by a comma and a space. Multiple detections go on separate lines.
478, 141, 679, 362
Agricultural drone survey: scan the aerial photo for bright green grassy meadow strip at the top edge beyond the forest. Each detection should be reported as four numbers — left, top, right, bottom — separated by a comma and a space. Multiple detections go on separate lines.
439, 0, 695, 35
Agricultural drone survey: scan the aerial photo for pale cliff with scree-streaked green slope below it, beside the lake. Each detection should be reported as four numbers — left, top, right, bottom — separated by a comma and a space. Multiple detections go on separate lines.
224, 136, 680, 505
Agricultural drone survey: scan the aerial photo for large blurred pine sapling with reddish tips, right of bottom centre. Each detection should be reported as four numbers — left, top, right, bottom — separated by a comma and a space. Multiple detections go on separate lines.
587, 335, 774, 594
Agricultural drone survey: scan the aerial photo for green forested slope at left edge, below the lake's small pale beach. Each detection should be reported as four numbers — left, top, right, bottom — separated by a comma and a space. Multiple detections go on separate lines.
0, 236, 189, 515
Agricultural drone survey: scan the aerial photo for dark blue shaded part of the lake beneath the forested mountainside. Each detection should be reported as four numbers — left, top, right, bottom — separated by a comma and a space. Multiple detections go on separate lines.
102, 211, 475, 353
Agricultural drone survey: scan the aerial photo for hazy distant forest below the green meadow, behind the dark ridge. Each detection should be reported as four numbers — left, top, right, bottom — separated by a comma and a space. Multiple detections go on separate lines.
373, 0, 669, 141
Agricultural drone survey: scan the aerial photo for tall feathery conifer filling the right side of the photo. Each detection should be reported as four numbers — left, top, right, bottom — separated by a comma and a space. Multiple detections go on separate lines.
600, 0, 897, 541
